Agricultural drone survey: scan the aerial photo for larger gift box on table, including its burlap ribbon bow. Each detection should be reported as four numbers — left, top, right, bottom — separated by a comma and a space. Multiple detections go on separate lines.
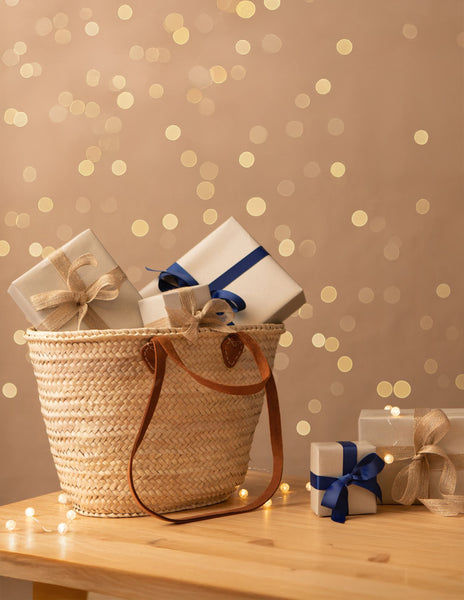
359, 408, 464, 504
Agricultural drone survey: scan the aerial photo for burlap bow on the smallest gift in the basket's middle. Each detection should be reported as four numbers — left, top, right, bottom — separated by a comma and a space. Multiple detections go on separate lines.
148, 287, 234, 342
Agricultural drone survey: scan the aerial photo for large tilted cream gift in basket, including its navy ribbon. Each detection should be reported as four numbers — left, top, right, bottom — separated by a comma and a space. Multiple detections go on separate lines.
141, 217, 305, 325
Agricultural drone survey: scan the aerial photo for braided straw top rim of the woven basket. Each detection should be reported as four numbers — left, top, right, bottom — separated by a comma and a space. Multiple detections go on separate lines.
24, 323, 285, 342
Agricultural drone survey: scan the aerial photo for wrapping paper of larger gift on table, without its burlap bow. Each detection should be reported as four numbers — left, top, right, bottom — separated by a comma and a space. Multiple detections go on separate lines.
359, 408, 464, 504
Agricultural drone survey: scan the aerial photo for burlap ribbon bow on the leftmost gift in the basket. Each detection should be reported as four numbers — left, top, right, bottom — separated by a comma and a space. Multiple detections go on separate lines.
30, 249, 126, 331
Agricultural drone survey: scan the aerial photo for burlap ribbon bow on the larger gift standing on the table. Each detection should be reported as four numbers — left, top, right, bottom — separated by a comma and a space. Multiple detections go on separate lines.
392, 409, 464, 516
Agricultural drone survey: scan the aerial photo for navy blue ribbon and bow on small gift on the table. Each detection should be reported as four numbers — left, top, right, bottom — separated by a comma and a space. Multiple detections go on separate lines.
310, 442, 385, 523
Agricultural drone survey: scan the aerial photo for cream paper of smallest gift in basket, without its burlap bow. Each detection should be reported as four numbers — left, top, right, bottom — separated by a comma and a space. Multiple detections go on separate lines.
139, 285, 211, 327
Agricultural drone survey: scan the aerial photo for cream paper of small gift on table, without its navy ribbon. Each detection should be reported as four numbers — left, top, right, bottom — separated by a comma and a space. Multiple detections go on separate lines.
311, 441, 377, 517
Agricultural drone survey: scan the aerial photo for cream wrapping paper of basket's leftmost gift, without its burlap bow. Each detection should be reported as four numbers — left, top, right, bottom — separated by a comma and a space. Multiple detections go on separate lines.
8, 229, 142, 331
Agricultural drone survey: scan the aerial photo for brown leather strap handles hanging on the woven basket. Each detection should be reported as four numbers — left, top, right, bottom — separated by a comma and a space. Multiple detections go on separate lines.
127, 332, 283, 523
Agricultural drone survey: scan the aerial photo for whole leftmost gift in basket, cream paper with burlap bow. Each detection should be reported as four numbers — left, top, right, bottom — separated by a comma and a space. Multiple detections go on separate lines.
8, 229, 142, 331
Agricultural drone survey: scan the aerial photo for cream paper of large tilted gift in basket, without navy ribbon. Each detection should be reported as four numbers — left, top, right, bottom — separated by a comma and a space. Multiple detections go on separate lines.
140, 217, 305, 325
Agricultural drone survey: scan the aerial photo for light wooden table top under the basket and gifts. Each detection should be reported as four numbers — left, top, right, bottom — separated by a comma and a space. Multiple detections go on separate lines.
0, 481, 464, 600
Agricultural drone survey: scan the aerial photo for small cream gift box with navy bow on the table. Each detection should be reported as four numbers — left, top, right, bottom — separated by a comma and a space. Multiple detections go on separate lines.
310, 441, 383, 522
